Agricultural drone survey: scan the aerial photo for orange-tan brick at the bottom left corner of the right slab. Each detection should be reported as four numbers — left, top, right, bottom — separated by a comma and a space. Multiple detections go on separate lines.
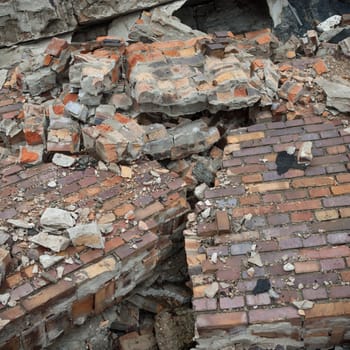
196, 312, 248, 332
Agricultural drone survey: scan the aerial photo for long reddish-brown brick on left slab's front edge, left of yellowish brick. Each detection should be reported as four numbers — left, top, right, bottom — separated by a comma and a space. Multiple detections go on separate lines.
22, 280, 74, 312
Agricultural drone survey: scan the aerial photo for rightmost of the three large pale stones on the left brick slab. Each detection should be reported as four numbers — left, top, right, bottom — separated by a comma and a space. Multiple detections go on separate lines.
67, 222, 104, 249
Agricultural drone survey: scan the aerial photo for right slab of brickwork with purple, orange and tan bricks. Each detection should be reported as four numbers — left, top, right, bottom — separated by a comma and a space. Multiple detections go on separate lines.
184, 117, 350, 349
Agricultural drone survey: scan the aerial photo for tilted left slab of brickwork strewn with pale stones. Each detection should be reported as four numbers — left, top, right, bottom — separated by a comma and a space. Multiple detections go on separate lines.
0, 157, 188, 350
